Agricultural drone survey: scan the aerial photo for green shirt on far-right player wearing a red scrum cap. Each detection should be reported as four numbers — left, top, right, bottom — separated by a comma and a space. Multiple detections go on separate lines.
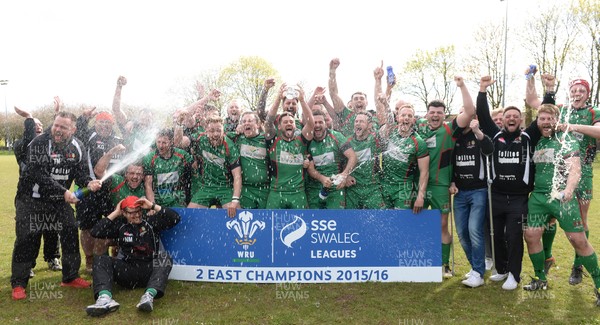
560, 105, 600, 166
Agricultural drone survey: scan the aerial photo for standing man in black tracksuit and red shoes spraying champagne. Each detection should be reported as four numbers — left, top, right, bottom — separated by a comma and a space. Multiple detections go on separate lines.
10, 112, 102, 300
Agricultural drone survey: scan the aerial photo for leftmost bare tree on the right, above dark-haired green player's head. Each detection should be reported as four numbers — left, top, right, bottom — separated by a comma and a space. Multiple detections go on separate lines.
398, 45, 456, 114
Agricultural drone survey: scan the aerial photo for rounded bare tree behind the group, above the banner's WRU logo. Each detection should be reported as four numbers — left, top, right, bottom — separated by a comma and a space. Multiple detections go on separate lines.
217, 56, 279, 110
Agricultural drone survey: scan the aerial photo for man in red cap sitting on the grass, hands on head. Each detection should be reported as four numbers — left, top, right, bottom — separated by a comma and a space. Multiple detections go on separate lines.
86, 196, 180, 316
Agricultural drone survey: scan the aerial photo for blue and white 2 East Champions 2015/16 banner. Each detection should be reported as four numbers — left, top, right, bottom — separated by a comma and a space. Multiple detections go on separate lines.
162, 208, 442, 283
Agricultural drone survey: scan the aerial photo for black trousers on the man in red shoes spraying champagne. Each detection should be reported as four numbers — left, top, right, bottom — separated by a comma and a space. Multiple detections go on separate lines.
10, 198, 81, 288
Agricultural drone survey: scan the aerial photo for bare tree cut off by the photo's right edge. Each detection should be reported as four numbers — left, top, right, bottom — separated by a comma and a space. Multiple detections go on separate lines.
573, 0, 600, 106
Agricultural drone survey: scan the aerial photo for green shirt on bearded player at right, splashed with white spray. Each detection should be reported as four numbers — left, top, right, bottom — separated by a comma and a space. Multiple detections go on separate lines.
533, 133, 580, 193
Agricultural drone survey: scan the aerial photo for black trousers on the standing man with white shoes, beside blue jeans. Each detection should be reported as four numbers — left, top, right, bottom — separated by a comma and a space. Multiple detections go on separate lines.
492, 193, 529, 282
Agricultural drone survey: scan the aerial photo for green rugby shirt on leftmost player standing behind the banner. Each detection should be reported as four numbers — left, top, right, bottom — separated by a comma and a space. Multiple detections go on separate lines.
144, 148, 192, 207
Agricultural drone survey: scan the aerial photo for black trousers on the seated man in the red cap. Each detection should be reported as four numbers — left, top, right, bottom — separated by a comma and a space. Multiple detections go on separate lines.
93, 252, 173, 299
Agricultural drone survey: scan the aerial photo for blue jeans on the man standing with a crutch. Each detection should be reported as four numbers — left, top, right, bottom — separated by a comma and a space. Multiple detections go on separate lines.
454, 188, 488, 277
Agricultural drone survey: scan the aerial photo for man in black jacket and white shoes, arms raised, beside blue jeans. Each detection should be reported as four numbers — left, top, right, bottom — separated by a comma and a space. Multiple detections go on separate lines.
476, 76, 554, 290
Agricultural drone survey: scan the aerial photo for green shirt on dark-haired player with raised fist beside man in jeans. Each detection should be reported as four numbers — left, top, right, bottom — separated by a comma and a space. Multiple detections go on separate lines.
417, 119, 457, 186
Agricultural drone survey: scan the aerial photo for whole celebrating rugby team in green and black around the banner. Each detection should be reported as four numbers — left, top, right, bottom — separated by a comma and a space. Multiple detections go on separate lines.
11, 58, 600, 316
